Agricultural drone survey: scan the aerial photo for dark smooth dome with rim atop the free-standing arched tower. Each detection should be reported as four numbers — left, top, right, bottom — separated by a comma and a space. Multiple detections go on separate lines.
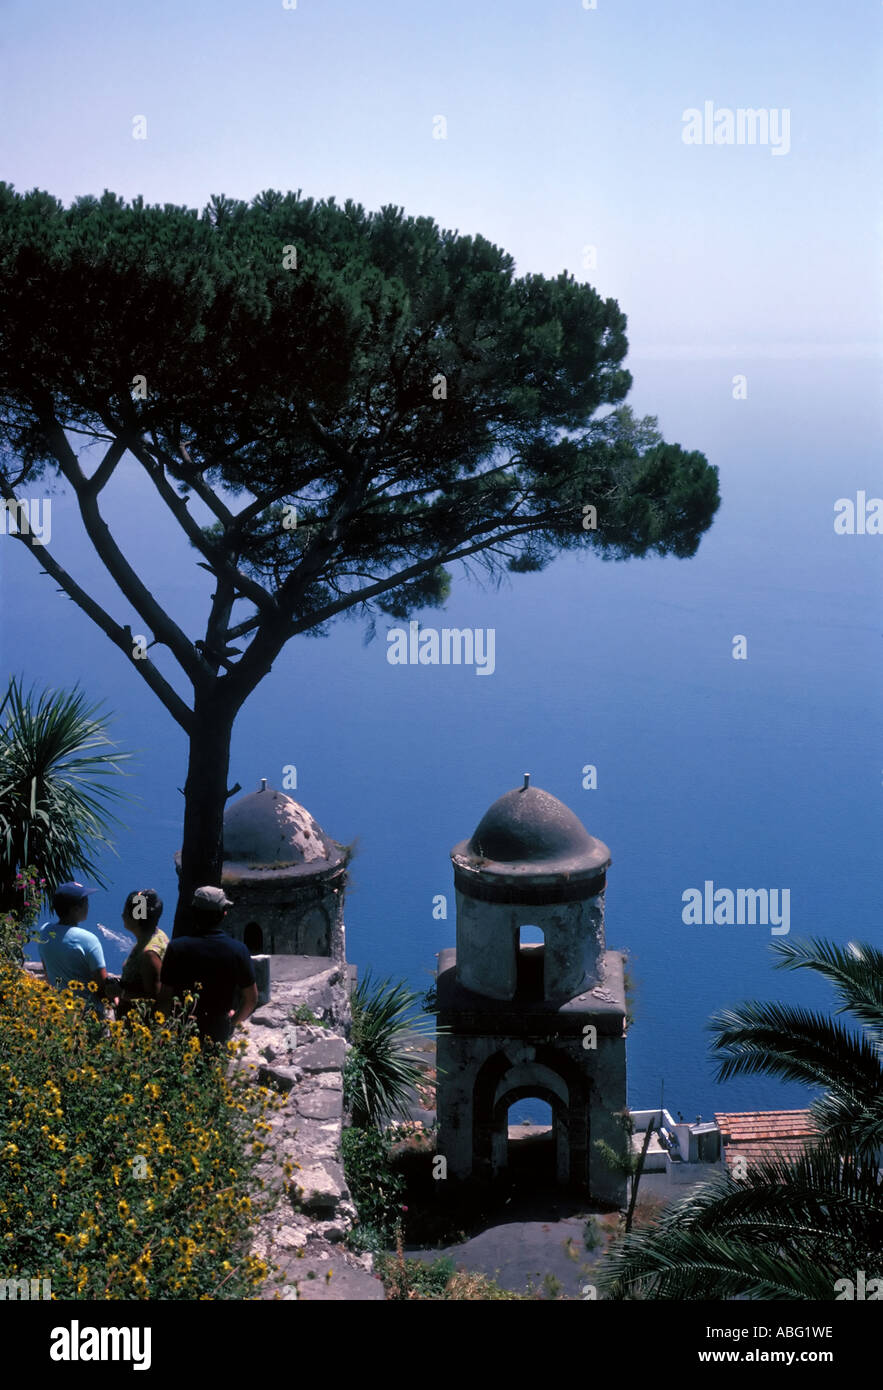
451, 774, 610, 883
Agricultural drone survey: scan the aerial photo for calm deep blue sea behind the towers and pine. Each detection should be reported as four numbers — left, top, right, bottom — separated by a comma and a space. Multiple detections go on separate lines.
0, 357, 883, 1118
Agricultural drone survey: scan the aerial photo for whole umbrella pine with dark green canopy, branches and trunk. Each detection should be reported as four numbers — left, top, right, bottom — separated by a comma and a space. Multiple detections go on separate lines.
0, 183, 719, 922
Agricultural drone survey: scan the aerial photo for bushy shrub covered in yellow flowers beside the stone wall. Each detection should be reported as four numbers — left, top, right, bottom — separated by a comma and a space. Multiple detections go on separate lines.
0, 959, 278, 1300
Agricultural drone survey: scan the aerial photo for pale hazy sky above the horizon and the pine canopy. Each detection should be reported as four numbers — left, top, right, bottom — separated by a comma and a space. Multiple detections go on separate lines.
0, 0, 883, 359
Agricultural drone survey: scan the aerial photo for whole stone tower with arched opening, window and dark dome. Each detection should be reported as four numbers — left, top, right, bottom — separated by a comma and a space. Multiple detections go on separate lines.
437, 776, 626, 1205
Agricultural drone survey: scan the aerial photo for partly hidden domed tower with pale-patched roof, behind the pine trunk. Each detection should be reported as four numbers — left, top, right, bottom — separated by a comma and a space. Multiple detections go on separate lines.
180, 778, 349, 963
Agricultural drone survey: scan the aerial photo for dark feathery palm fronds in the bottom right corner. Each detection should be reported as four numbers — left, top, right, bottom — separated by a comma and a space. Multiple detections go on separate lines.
599, 941, 883, 1300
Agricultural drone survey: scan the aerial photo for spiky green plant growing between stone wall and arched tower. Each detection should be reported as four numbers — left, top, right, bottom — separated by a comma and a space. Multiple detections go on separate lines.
343, 970, 432, 1126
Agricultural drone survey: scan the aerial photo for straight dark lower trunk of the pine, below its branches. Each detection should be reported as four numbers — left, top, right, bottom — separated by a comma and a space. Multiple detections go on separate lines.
172, 695, 236, 937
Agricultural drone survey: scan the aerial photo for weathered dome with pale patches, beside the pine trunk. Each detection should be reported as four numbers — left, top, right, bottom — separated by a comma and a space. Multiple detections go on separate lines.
224, 778, 346, 877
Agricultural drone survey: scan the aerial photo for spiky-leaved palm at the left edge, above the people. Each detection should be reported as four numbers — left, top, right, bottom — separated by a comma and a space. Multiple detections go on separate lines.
0, 680, 131, 910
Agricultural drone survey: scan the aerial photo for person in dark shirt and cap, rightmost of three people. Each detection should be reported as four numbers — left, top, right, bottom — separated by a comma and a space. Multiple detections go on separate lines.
157, 887, 257, 1043
